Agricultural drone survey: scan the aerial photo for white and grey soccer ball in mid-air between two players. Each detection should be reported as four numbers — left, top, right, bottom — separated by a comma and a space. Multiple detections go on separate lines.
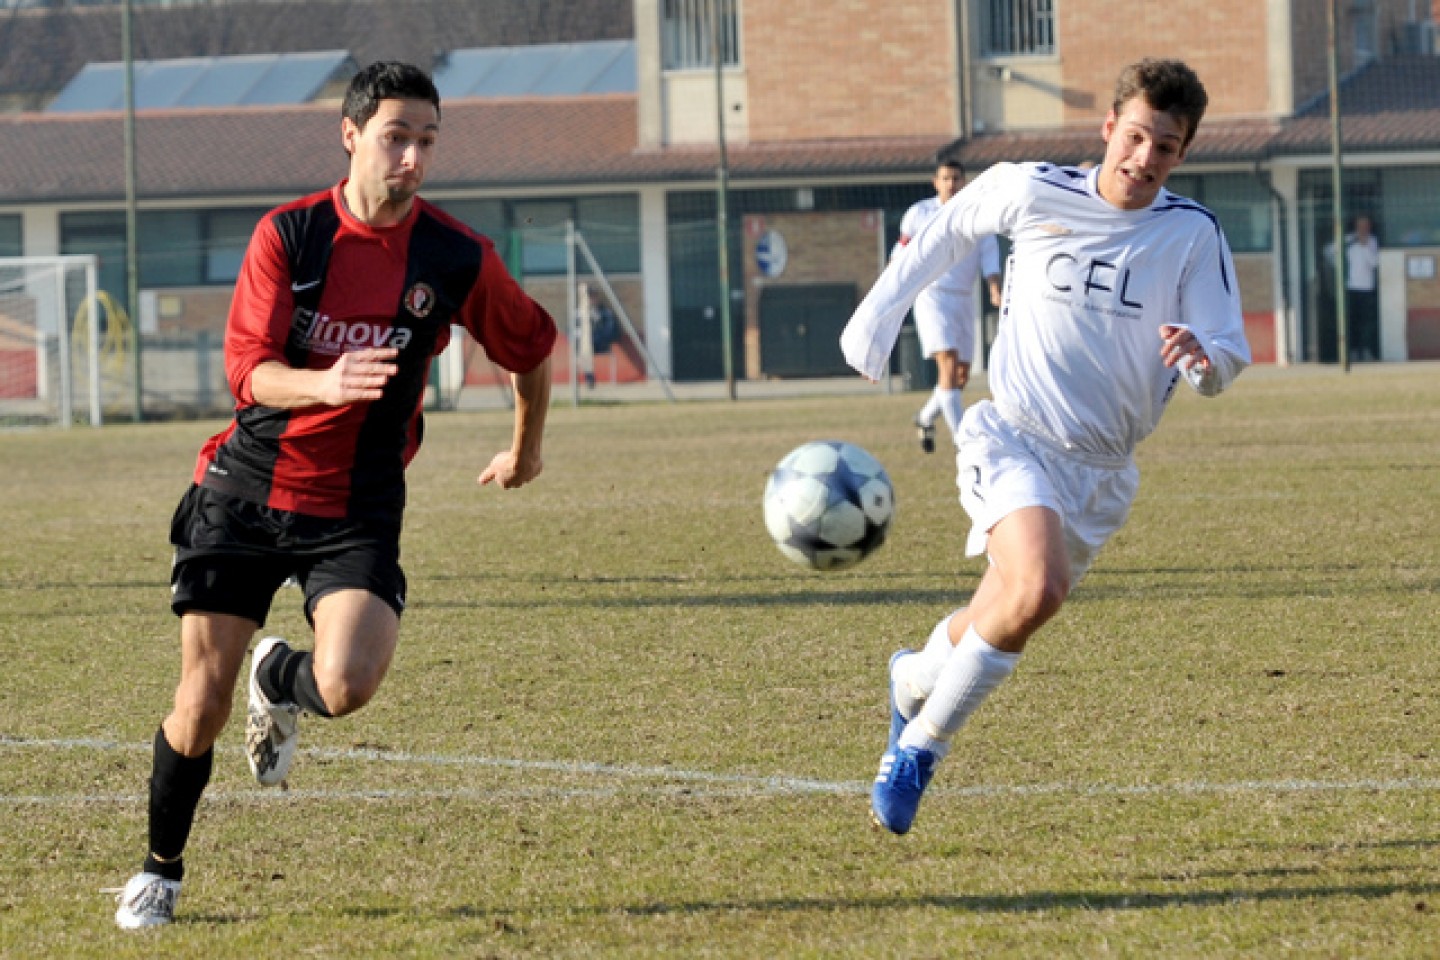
765, 440, 896, 570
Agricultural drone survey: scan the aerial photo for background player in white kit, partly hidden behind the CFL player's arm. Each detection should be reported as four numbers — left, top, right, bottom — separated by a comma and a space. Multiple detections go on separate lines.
890, 148, 999, 453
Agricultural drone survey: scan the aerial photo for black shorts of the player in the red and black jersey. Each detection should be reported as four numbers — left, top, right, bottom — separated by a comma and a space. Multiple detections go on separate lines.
170, 485, 406, 626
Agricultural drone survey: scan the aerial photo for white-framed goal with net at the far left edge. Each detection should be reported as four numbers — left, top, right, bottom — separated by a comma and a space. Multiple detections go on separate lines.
0, 255, 104, 427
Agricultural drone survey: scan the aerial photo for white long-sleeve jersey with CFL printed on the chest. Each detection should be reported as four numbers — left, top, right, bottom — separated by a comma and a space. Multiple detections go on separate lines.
840, 163, 1250, 458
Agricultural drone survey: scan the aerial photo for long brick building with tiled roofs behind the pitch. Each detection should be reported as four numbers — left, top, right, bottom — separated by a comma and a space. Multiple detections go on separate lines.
0, 0, 1440, 414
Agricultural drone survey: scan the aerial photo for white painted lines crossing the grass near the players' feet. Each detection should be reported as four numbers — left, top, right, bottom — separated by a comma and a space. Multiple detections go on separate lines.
0, 735, 1440, 807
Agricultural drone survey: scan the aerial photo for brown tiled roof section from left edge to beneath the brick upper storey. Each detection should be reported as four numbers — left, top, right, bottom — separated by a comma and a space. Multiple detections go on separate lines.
0, 94, 942, 203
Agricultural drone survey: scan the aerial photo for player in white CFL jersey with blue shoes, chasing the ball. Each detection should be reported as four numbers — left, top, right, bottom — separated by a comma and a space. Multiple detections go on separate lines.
841, 60, 1250, 833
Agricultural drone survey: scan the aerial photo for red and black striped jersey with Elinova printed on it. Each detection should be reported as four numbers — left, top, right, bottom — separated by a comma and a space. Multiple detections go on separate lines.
194, 181, 556, 522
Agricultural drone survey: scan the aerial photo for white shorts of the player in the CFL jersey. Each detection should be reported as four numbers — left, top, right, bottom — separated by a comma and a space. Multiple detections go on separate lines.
955, 400, 1140, 583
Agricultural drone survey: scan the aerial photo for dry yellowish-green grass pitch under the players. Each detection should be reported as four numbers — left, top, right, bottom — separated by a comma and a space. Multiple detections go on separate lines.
0, 366, 1440, 960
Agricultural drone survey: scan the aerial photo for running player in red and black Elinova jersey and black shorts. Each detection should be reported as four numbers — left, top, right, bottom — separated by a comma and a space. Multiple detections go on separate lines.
115, 63, 556, 928
